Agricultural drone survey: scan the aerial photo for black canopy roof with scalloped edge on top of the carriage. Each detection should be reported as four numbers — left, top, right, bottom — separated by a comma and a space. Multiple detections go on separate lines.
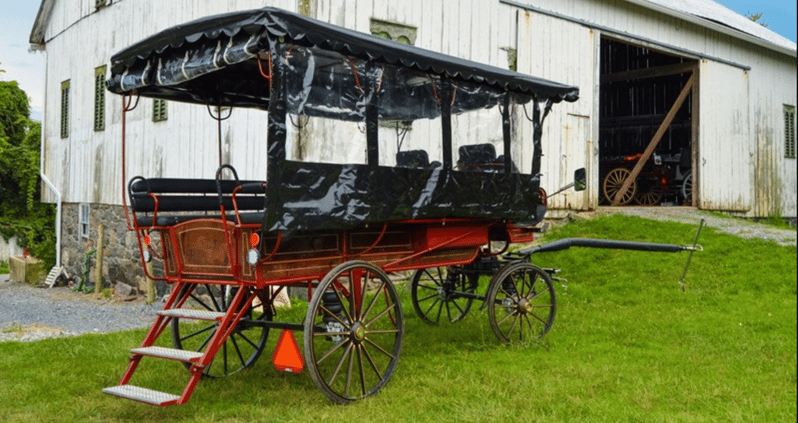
106, 7, 579, 108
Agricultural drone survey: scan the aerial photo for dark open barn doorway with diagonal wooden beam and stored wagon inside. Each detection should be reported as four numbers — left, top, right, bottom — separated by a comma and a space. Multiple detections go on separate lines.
599, 37, 698, 206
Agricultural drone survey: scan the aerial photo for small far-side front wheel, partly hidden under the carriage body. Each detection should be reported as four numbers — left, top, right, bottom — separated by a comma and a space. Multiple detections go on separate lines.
411, 267, 479, 325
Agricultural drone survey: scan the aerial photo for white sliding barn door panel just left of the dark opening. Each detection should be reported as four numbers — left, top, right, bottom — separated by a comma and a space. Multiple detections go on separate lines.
518, 12, 599, 210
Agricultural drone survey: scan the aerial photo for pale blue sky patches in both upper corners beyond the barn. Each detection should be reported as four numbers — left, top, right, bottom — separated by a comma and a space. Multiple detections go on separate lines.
0, 0, 796, 120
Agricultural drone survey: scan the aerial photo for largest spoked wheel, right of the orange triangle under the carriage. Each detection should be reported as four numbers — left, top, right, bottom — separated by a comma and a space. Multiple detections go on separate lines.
304, 261, 404, 404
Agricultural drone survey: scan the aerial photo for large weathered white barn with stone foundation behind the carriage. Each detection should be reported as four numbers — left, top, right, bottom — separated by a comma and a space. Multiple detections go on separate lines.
30, 0, 796, 285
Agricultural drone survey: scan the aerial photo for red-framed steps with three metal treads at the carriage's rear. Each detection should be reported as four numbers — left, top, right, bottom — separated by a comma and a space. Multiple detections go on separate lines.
103, 283, 252, 406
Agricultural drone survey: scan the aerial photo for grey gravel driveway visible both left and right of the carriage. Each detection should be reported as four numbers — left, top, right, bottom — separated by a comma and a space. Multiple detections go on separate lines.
0, 207, 796, 342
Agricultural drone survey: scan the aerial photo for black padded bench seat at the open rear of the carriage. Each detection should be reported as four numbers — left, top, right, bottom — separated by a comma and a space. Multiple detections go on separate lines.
128, 176, 266, 226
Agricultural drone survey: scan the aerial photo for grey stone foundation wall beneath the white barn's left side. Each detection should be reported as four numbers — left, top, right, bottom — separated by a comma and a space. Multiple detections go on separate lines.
61, 203, 167, 295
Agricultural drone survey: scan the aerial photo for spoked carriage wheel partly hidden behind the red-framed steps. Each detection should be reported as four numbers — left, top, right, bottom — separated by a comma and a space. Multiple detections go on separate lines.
172, 284, 272, 377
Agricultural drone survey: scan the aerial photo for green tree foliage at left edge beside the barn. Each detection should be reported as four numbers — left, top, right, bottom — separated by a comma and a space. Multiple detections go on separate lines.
0, 69, 55, 267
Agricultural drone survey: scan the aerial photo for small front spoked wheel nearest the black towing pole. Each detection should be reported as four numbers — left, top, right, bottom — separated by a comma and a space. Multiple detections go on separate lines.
485, 262, 557, 342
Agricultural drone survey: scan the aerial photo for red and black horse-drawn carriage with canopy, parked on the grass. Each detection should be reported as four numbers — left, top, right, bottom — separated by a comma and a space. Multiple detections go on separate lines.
104, 8, 700, 405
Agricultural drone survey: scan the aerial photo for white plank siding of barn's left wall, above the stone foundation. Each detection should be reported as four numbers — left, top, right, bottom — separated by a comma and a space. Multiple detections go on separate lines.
44, 0, 296, 204
